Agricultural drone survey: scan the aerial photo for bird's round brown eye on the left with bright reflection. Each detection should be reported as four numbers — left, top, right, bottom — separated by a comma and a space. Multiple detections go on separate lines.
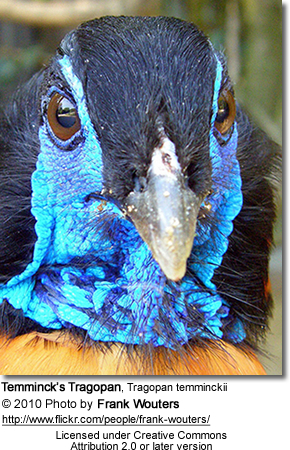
47, 93, 81, 141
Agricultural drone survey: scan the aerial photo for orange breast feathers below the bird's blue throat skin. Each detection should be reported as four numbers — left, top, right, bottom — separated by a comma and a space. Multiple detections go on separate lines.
0, 332, 266, 375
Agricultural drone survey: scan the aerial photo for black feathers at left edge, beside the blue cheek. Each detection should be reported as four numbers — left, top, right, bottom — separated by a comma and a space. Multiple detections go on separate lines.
0, 73, 43, 283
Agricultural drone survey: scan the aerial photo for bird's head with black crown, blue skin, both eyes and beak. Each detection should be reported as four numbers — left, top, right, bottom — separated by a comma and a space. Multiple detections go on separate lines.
1, 18, 276, 348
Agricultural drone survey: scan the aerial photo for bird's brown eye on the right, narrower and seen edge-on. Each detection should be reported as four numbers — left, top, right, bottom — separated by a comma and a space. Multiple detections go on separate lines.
215, 90, 236, 134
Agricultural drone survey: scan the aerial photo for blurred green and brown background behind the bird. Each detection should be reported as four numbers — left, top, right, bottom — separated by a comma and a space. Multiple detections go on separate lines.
0, 0, 282, 375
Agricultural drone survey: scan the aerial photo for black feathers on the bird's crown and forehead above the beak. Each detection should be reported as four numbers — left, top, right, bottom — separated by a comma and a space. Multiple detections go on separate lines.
61, 17, 215, 199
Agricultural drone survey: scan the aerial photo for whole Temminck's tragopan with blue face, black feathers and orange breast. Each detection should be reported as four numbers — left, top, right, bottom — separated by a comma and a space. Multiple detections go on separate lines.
0, 16, 281, 376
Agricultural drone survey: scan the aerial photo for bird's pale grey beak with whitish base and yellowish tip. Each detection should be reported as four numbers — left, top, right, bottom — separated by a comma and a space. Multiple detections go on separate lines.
125, 137, 202, 281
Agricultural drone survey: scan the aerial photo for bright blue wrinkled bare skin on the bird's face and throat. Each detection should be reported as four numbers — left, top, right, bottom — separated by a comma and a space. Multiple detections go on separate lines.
0, 52, 245, 349
